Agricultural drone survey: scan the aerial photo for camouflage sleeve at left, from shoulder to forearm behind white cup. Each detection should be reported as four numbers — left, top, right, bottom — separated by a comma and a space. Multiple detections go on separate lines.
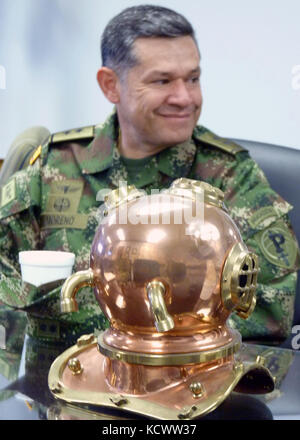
0, 161, 108, 343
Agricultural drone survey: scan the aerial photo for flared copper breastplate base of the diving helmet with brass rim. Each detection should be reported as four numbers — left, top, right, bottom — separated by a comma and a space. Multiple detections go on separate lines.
49, 344, 274, 420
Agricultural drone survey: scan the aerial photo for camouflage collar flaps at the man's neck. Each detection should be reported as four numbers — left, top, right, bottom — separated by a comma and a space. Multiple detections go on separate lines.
81, 110, 196, 187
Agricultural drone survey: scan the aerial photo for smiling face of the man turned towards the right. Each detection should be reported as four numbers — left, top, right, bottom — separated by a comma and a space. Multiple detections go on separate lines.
117, 36, 202, 153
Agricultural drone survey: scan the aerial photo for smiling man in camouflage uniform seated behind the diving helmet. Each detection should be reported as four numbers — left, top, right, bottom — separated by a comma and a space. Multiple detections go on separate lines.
0, 5, 299, 342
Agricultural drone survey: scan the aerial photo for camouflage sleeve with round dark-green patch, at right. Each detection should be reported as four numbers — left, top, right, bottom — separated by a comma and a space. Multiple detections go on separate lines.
221, 151, 300, 343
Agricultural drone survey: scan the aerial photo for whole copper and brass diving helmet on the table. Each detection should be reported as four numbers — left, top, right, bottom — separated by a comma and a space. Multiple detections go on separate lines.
49, 178, 274, 419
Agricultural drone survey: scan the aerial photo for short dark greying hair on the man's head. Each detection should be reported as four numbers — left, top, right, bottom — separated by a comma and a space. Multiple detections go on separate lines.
101, 5, 198, 76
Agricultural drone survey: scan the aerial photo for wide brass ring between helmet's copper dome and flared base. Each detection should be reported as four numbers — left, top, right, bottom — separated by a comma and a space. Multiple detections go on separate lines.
98, 333, 241, 366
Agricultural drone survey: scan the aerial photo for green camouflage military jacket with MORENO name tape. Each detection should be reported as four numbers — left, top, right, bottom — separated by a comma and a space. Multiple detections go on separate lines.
0, 113, 300, 341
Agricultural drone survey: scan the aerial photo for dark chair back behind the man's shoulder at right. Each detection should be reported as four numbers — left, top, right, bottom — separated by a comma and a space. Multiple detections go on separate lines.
232, 139, 300, 325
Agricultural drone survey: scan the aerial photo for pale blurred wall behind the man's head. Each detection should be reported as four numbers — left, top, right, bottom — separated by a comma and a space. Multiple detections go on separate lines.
0, 0, 300, 157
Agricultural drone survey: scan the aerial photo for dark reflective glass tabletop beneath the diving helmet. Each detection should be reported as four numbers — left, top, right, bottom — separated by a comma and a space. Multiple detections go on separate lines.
0, 311, 300, 420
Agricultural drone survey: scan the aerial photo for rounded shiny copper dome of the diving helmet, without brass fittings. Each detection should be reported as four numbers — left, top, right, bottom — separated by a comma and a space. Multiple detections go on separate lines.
91, 195, 241, 350
